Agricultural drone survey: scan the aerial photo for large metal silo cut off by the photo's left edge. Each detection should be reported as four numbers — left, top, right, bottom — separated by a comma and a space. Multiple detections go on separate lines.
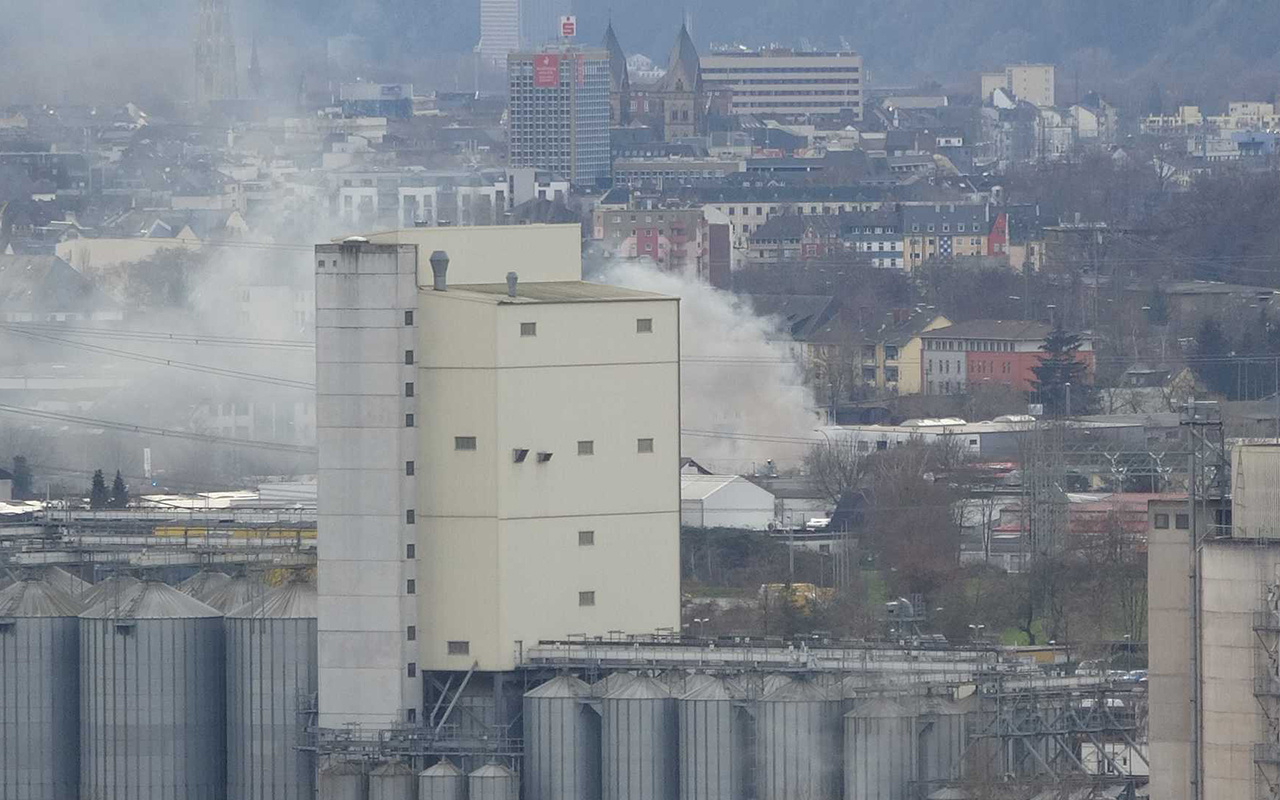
0, 581, 82, 800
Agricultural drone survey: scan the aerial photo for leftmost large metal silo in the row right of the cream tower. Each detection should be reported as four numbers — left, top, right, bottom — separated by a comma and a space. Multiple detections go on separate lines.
524, 675, 600, 800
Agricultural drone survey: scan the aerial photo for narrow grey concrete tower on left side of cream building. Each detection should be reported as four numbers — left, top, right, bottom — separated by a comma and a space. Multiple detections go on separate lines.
316, 244, 421, 727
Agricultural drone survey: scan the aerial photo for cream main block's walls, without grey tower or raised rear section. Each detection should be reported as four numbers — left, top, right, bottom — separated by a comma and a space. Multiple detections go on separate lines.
417, 285, 680, 671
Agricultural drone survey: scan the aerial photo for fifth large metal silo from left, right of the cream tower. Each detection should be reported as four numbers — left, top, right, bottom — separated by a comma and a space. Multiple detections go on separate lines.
845, 700, 915, 800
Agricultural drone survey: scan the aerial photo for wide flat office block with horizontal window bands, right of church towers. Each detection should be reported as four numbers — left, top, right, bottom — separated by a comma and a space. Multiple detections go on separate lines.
701, 49, 867, 120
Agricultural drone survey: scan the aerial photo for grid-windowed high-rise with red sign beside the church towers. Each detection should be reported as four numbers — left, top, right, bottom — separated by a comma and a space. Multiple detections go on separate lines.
507, 45, 611, 187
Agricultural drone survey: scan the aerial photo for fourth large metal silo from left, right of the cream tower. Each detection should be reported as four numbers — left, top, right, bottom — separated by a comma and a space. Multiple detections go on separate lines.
755, 680, 844, 800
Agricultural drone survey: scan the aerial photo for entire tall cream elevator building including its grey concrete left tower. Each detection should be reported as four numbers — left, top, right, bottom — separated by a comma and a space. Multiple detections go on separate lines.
316, 225, 680, 727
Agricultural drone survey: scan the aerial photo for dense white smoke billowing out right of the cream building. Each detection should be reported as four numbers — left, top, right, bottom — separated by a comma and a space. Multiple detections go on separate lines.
600, 261, 817, 474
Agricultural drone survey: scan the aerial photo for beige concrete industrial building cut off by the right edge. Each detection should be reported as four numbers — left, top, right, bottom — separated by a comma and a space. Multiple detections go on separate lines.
1148, 442, 1280, 800
